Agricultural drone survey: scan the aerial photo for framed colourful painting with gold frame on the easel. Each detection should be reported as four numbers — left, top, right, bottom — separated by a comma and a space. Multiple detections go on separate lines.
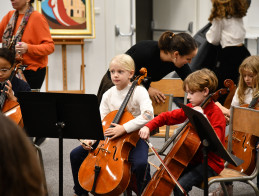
35, 0, 95, 38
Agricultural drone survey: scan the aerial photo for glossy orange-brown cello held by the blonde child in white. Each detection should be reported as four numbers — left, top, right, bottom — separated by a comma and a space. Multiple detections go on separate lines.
78, 68, 147, 196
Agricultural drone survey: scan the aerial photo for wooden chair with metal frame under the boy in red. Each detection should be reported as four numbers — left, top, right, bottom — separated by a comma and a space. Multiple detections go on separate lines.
208, 106, 259, 196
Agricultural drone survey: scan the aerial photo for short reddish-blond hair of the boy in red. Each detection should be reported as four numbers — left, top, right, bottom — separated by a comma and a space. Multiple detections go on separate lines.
183, 68, 218, 93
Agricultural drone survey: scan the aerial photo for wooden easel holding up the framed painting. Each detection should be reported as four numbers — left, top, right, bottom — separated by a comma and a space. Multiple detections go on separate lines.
46, 38, 85, 94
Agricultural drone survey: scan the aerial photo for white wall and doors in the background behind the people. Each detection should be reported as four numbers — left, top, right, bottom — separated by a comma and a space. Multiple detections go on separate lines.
0, 0, 259, 94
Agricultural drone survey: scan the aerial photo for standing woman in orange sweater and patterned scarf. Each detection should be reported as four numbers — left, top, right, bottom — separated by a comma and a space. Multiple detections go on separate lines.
0, 0, 54, 89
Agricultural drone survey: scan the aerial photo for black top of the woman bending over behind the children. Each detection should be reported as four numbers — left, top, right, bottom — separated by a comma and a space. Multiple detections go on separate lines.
109, 40, 192, 88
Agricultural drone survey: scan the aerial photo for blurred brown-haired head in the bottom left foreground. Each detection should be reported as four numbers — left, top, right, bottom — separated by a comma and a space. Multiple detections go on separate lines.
0, 114, 46, 196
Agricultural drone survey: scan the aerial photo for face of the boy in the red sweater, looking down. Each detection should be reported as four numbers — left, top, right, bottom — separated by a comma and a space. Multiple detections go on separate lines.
186, 86, 208, 106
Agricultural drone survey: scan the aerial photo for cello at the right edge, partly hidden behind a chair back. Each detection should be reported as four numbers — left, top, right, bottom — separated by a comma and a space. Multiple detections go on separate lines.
225, 95, 259, 175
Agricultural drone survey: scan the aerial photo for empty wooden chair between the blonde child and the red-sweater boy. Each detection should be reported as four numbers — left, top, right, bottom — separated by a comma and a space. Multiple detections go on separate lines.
151, 78, 187, 141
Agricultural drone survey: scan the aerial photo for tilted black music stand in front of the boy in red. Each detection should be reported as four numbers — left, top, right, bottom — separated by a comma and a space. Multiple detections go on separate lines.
179, 103, 244, 196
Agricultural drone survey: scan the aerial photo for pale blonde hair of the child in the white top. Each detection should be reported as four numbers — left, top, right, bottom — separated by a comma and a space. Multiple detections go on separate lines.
109, 54, 135, 71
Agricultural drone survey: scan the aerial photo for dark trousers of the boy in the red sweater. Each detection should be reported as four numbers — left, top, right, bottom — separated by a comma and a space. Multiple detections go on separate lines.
174, 163, 217, 196
